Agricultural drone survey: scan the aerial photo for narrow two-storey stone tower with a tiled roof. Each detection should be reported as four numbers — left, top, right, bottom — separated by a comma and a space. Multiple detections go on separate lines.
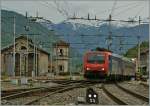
53, 40, 69, 74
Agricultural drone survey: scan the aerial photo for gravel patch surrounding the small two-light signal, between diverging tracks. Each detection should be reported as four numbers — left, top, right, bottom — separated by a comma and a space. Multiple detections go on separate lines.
36, 84, 116, 105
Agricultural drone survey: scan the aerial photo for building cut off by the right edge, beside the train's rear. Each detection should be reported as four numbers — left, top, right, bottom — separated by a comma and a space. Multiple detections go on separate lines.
140, 49, 149, 74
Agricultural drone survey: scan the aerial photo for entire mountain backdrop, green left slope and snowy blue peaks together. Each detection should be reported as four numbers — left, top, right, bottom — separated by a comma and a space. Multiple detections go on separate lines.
1, 10, 149, 70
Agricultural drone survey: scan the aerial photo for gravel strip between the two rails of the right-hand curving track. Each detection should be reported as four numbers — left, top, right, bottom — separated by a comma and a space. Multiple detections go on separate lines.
105, 84, 148, 105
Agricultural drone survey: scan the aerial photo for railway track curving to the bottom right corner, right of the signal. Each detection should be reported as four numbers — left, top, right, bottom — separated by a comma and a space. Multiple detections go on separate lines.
99, 83, 149, 105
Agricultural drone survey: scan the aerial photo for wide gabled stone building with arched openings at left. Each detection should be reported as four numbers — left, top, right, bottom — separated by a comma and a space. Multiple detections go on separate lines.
1, 36, 49, 77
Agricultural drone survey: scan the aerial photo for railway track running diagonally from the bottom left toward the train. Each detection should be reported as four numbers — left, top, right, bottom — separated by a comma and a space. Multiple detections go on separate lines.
1, 81, 95, 105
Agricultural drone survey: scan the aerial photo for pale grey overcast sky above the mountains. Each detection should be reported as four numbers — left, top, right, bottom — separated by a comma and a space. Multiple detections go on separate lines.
1, 0, 150, 23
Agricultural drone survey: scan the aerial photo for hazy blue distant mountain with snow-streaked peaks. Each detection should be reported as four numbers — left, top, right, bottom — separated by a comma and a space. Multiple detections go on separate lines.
42, 20, 149, 54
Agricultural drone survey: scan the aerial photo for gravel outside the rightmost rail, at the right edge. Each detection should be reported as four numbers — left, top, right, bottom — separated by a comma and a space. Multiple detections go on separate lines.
119, 82, 149, 97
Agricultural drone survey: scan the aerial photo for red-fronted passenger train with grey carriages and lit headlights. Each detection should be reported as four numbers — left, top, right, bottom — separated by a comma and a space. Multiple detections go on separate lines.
83, 51, 136, 79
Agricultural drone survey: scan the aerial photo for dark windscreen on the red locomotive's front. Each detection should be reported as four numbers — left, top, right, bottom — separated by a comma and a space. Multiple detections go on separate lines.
87, 54, 105, 64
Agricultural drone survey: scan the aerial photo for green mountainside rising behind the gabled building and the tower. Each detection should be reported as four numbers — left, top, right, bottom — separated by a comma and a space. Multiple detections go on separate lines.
1, 10, 82, 71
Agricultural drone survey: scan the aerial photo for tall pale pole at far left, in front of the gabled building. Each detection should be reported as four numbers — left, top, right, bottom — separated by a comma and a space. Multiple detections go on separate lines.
13, 16, 16, 76
